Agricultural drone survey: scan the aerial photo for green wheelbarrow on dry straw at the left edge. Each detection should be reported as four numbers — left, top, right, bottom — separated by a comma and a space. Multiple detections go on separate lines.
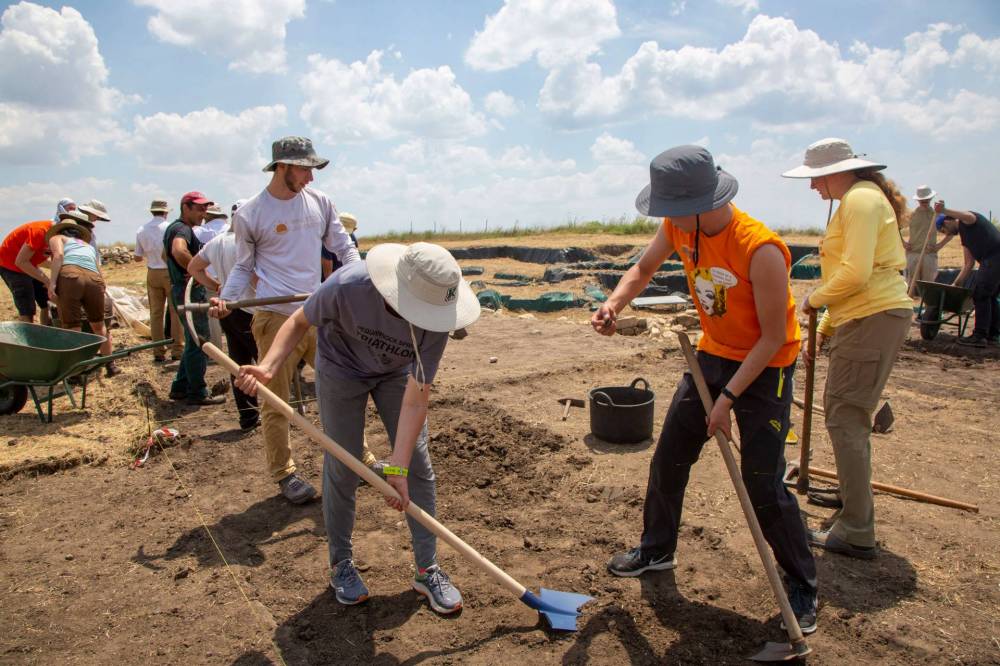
0, 321, 173, 423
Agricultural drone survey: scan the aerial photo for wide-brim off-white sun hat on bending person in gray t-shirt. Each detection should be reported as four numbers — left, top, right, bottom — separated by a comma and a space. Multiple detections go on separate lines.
365, 243, 480, 333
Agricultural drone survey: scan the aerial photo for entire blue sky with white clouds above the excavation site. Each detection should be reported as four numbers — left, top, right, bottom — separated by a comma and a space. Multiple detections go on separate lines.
0, 0, 1000, 242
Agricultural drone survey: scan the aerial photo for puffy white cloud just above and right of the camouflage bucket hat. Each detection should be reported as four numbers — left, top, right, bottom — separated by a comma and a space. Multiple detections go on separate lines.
299, 51, 486, 142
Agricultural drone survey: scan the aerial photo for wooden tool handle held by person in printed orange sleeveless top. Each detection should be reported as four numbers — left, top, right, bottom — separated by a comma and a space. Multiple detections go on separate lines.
677, 333, 806, 653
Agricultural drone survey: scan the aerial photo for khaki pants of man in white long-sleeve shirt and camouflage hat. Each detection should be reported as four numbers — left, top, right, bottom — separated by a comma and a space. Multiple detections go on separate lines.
252, 310, 316, 481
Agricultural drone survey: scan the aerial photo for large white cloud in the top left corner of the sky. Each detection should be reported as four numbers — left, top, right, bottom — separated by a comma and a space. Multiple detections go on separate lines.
0, 2, 130, 164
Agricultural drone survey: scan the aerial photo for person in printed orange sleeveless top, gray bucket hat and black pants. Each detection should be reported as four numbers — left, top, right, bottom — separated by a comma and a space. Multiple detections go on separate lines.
591, 146, 817, 634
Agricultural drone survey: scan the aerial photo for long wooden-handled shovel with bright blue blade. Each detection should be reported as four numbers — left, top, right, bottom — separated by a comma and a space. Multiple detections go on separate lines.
185, 286, 588, 631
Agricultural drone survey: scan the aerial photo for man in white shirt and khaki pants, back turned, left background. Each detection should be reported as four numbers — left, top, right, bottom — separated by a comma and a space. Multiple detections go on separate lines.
134, 199, 184, 363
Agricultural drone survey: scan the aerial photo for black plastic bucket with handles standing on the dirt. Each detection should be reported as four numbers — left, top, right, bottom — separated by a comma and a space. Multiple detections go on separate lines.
588, 377, 656, 444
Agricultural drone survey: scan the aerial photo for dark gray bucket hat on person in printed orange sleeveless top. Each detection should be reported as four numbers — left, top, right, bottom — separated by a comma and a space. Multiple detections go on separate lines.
635, 146, 740, 217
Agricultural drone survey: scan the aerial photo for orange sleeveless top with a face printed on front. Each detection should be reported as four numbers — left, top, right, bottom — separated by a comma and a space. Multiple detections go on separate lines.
663, 206, 802, 368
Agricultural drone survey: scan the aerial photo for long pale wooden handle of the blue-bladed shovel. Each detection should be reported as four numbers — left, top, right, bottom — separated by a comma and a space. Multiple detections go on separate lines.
201, 342, 526, 598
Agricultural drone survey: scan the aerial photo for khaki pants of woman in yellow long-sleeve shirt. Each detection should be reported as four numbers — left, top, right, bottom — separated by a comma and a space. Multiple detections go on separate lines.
823, 309, 913, 548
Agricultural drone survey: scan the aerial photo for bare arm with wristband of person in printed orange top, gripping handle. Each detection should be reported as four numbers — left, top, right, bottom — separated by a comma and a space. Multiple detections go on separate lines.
708, 243, 789, 439
